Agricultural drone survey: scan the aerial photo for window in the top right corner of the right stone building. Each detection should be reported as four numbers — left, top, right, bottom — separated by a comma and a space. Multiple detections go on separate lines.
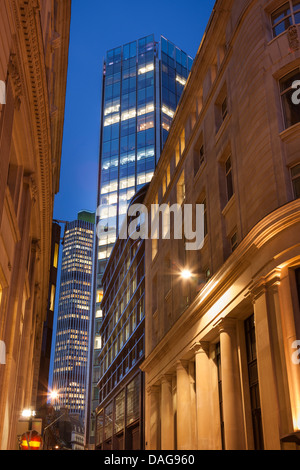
271, 0, 300, 38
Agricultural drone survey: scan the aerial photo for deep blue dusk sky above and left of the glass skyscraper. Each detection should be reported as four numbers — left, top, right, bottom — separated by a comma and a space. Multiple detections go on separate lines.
54, 0, 215, 221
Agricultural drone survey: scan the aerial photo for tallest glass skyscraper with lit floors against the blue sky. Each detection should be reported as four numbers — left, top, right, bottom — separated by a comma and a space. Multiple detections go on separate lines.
88, 35, 193, 448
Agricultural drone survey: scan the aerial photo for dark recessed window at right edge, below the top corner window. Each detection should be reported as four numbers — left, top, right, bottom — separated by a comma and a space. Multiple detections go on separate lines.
280, 69, 300, 128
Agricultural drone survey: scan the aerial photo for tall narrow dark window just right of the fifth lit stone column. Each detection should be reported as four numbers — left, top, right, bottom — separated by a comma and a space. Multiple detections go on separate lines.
245, 315, 264, 450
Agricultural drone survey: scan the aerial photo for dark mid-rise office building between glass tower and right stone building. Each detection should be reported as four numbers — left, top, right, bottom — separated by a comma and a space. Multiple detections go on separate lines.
95, 184, 148, 450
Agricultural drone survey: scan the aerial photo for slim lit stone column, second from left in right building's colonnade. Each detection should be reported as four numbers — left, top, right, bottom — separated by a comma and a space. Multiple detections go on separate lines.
160, 375, 174, 450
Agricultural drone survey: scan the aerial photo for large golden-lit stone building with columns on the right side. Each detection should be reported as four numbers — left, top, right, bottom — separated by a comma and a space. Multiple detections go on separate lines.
142, 0, 300, 450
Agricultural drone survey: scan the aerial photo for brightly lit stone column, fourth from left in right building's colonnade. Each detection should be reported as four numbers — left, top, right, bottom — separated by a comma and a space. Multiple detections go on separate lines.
192, 343, 213, 450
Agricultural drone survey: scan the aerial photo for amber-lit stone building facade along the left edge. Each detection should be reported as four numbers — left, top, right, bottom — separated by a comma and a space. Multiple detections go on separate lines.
0, 0, 71, 449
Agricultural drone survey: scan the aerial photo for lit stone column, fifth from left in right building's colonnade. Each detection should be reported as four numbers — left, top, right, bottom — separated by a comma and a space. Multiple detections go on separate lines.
219, 319, 245, 450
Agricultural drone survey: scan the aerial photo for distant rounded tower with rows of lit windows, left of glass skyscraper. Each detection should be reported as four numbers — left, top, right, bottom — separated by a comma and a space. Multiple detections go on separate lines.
52, 212, 95, 418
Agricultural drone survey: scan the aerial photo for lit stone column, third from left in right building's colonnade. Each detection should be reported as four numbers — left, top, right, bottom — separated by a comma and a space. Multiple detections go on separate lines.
176, 361, 192, 450
